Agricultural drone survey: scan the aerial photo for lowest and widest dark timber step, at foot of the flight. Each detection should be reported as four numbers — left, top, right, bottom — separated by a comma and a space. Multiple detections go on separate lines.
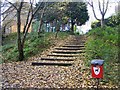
32, 62, 73, 66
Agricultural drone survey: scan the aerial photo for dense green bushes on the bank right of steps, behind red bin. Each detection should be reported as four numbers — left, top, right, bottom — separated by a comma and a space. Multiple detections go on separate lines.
85, 27, 118, 85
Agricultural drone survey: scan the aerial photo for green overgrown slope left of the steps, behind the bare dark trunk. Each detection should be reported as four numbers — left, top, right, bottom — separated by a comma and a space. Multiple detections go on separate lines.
2, 32, 69, 61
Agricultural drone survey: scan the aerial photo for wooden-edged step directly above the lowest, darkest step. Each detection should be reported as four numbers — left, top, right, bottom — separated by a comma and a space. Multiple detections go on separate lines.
41, 57, 75, 61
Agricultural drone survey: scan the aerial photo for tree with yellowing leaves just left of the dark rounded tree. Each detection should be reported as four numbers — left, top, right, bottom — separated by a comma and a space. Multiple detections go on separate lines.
36, 2, 66, 37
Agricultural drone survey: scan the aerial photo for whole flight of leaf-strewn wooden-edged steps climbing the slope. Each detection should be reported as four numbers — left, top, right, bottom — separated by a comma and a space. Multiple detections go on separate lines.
32, 36, 85, 66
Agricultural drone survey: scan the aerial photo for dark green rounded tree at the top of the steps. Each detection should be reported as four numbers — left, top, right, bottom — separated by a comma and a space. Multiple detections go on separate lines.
66, 2, 89, 32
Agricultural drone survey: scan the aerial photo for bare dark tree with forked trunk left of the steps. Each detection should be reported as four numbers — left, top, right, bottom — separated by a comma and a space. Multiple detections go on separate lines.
5, 0, 43, 61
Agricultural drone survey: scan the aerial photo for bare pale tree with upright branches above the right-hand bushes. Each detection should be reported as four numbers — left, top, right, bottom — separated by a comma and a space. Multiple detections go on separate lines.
87, 0, 109, 27
